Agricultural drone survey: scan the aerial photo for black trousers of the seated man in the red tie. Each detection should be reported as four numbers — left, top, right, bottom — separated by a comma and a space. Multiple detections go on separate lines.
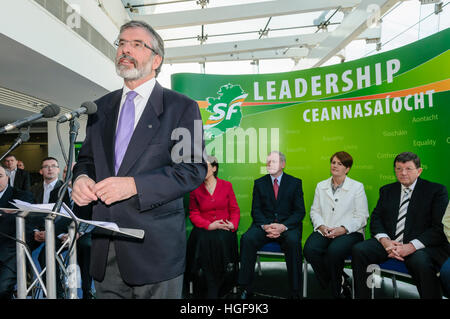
238, 225, 303, 296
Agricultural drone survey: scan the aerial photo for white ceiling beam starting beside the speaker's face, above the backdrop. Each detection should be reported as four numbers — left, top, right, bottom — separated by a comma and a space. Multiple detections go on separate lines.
164, 32, 329, 63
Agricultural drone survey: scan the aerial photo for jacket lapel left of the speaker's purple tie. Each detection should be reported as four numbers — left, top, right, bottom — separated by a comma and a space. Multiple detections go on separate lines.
102, 90, 123, 176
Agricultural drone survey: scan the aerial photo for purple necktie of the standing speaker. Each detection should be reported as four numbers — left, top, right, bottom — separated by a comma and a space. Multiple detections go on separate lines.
114, 91, 137, 175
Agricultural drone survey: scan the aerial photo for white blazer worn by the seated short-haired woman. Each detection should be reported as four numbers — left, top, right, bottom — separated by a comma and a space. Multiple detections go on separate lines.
310, 176, 369, 236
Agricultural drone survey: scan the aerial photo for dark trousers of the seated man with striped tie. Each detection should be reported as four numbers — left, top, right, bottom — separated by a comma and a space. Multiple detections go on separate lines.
352, 238, 445, 299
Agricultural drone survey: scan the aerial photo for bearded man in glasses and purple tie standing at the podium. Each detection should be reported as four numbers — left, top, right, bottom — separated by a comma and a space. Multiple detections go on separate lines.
72, 21, 207, 299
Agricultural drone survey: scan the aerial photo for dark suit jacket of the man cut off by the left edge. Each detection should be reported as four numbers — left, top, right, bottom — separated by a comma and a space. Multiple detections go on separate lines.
0, 185, 33, 262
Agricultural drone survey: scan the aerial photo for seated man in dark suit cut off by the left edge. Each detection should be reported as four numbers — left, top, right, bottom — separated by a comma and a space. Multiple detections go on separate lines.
0, 166, 32, 299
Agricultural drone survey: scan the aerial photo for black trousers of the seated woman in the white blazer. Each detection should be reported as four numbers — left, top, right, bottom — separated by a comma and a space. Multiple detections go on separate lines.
303, 232, 364, 298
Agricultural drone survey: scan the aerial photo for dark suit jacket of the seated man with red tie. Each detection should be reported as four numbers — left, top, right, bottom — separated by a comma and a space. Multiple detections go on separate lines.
252, 173, 305, 230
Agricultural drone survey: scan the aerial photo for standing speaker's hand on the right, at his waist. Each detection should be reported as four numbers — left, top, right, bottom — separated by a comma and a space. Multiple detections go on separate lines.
93, 177, 137, 205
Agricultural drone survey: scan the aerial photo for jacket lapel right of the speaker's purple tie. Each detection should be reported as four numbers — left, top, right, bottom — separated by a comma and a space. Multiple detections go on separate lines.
118, 82, 163, 176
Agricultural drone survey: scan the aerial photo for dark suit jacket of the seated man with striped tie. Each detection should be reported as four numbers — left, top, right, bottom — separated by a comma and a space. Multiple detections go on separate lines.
370, 178, 448, 247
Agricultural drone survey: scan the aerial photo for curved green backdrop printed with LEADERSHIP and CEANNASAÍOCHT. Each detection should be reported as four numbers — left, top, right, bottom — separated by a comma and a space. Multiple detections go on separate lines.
172, 29, 450, 243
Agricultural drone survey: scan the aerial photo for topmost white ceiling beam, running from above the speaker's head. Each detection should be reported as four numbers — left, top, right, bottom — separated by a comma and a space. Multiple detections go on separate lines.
138, 0, 361, 29
